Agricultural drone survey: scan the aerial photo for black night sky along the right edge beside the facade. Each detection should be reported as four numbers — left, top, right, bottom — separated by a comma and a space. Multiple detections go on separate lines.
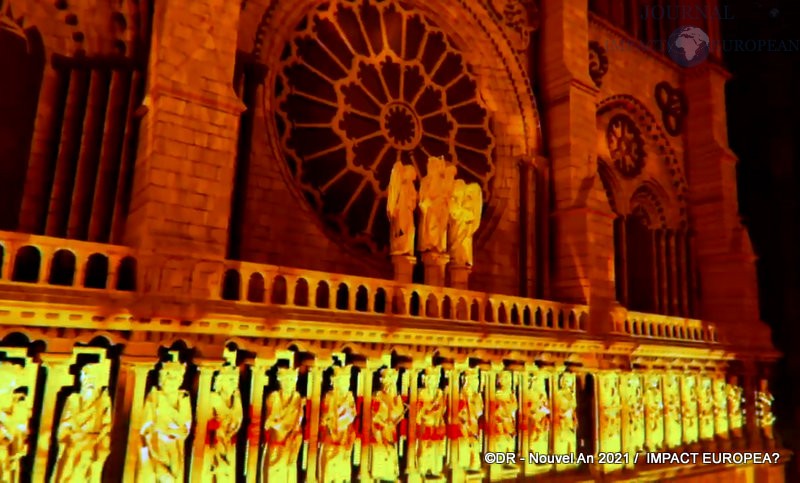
720, 0, 800, 481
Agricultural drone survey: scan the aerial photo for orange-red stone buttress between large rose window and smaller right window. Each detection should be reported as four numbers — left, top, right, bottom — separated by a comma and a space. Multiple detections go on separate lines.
540, 0, 616, 332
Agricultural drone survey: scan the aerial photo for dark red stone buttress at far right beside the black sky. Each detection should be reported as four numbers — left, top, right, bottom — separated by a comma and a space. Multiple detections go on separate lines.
683, 62, 772, 350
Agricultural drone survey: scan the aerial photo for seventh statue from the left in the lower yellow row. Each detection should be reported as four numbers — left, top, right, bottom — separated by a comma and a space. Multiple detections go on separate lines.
370, 367, 406, 481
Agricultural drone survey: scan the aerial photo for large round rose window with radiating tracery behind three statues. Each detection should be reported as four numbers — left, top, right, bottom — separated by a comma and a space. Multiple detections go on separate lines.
275, 0, 495, 255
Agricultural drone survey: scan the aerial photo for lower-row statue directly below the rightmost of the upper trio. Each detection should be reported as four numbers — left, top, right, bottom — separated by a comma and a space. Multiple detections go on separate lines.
456, 368, 484, 471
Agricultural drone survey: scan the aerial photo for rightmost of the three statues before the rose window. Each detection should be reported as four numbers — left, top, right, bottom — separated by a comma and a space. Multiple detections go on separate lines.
447, 179, 483, 267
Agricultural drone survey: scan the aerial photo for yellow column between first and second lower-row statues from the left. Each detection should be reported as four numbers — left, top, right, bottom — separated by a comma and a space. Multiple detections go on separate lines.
31, 354, 74, 483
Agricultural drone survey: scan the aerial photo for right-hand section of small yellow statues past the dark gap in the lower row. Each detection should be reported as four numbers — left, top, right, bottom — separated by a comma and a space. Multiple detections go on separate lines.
597, 371, 774, 464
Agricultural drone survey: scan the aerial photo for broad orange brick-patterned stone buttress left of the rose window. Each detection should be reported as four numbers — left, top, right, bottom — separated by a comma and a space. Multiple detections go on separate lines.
125, 0, 244, 258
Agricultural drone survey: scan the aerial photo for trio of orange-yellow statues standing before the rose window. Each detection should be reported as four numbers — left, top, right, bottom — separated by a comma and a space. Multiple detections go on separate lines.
386, 157, 483, 267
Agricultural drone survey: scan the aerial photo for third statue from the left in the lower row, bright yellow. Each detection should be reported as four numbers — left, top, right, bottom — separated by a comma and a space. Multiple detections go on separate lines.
136, 351, 193, 483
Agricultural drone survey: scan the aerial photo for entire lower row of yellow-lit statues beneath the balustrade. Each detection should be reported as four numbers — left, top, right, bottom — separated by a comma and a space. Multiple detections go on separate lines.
0, 352, 775, 483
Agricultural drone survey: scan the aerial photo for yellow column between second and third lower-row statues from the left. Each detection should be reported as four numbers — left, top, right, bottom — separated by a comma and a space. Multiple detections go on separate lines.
117, 360, 155, 483
